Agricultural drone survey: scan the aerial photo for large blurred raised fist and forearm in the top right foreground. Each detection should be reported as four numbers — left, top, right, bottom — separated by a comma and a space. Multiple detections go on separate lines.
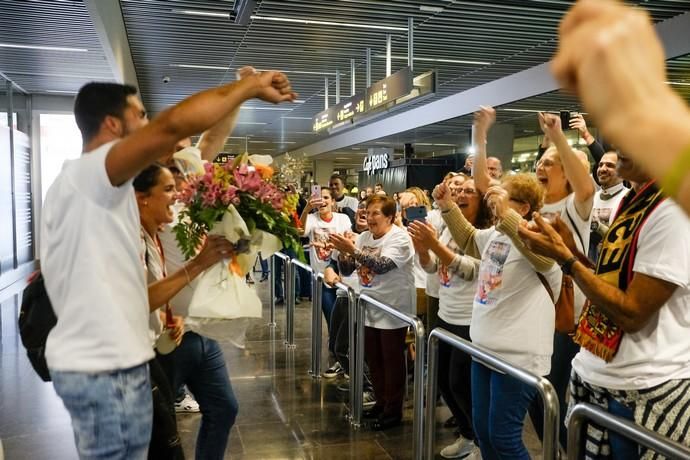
551, 0, 690, 213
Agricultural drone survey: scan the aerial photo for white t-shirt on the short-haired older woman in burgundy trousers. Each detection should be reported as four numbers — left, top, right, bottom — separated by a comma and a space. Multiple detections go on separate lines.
355, 225, 417, 329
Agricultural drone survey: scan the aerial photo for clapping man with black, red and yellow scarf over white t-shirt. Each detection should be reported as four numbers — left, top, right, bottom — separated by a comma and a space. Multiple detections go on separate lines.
520, 154, 690, 459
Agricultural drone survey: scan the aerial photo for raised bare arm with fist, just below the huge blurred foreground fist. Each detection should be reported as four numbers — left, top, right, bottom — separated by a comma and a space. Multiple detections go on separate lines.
539, 113, 594, 219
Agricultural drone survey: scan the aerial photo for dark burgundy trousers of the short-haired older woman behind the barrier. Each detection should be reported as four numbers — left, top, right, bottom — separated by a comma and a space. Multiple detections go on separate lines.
364, 326, 407, 418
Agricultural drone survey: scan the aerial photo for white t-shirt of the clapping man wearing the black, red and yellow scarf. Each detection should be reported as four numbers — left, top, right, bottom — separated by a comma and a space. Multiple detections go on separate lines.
573, 199, 690, 390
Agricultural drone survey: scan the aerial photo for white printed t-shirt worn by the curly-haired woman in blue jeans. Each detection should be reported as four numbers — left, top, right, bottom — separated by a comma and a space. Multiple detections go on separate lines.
470, 228, 561, 375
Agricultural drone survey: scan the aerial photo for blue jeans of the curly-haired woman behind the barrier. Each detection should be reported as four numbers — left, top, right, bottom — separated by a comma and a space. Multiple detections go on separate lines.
472, 361, 537, 460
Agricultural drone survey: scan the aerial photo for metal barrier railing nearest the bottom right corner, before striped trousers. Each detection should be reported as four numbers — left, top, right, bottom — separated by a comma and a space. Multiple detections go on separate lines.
568, 403, 690, 460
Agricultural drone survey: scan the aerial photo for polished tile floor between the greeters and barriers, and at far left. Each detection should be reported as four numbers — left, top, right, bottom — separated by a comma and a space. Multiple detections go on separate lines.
0, 274, 540, 460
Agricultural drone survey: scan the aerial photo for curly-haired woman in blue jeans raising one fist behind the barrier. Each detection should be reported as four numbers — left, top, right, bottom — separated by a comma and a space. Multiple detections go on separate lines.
434, 174, 561, 460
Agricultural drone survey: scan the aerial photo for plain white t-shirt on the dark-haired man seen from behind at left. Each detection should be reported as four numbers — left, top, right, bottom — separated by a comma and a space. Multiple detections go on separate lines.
40, 142, 153, 373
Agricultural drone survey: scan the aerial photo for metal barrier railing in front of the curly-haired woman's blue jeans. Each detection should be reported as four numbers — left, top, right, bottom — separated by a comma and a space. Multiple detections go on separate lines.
425, 327, 559, 460
